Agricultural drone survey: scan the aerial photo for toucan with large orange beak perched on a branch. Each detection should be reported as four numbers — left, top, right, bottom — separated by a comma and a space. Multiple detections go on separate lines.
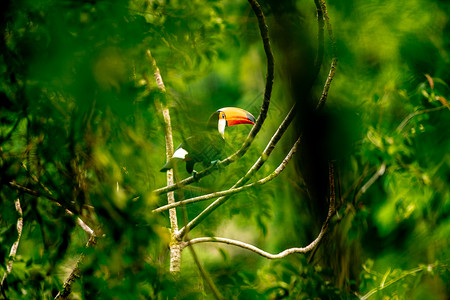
161, 107, 255, 175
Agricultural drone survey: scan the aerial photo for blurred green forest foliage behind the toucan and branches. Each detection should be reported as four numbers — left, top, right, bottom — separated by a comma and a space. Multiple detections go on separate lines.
0, 0, 450, 300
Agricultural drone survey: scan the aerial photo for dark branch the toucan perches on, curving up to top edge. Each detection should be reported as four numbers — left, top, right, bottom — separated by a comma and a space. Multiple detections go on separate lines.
153, 0, 274, 195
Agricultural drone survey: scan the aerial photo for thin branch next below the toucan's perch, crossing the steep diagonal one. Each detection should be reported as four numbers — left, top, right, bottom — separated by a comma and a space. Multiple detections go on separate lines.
152, 138, 300, 213
